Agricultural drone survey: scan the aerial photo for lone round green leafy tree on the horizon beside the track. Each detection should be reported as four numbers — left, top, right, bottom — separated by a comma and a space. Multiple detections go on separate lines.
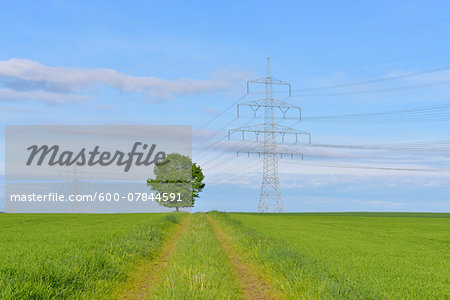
147, 153, 205, 211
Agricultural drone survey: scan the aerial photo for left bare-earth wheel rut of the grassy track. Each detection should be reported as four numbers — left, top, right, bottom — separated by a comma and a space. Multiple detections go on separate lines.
116, 214, 191, 299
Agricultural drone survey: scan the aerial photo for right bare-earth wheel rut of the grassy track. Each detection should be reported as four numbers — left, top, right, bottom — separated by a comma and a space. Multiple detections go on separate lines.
206, 215, 283, 299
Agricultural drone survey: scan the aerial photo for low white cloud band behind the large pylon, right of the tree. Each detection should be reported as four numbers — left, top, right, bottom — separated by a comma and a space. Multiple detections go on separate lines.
199, 149, 450, 188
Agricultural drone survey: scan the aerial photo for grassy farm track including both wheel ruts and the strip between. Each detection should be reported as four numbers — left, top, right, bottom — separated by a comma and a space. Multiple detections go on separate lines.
117, 213, 281, 299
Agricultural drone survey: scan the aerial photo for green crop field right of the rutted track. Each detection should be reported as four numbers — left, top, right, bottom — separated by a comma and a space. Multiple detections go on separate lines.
212, 213, 450, 299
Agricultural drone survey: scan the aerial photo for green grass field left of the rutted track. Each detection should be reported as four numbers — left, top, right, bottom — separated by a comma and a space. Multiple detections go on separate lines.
0, 214, 185, 299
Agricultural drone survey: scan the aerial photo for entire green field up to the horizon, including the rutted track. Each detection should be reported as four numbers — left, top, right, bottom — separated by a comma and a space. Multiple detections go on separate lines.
0, 212, 450, 299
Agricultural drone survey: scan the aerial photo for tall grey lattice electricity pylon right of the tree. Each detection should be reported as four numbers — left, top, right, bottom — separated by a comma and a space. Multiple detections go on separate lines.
228, 57, 311, 212
